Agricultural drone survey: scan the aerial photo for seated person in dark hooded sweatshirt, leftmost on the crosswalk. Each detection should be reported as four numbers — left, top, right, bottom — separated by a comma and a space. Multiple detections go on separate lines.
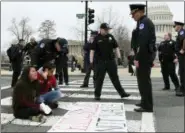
12, 66, 51, 122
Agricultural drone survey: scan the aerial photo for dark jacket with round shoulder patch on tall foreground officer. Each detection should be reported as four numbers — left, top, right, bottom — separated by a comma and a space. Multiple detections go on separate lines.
135, 16, 157, 63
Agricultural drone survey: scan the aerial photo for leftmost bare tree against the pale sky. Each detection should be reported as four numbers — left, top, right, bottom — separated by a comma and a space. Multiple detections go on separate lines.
8, 17, 33, 42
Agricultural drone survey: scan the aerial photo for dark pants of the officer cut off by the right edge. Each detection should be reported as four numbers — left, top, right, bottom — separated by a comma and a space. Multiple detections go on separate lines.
179, 54, 185, 93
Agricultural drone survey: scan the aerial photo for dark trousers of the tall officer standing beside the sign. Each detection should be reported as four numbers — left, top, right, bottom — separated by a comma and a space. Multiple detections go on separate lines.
136, 63, 153, 110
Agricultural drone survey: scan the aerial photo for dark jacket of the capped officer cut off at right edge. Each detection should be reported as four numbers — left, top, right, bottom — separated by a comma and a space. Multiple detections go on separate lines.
176, 29, 185, 55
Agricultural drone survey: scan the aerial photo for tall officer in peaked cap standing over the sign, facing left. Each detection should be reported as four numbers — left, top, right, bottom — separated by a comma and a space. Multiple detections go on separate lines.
130, 4, 157, 112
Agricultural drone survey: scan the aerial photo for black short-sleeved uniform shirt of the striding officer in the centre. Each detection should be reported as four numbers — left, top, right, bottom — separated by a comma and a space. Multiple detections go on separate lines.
90, 34, 118, 60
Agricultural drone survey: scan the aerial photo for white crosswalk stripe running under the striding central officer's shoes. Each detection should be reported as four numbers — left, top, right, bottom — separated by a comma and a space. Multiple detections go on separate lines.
70, 94, 141, 100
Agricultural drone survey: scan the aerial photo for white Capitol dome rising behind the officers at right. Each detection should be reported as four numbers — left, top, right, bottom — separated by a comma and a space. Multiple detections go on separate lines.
148, 2, 176, 43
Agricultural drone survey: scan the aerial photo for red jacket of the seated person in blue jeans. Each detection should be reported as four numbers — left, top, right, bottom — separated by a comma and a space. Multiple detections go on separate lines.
37, 73, 57, 95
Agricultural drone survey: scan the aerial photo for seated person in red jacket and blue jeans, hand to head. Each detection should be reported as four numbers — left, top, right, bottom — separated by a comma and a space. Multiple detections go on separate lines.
37, 63, 62, 109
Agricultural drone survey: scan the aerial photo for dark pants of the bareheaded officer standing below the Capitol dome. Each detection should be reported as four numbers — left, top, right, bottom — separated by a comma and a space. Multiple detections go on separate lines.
161, 62, 179, 89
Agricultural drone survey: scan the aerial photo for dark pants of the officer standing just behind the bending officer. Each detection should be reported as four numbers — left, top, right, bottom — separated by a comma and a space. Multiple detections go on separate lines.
59, 66, 69, 83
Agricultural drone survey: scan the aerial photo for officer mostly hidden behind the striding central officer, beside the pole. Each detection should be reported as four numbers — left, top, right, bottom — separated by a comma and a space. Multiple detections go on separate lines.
80, 31, 98, 88
